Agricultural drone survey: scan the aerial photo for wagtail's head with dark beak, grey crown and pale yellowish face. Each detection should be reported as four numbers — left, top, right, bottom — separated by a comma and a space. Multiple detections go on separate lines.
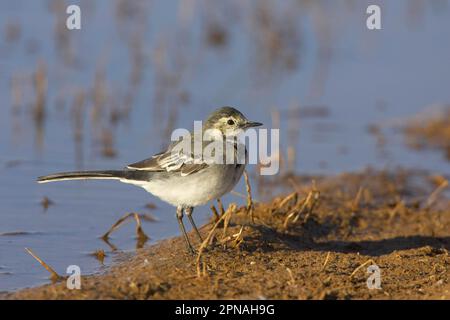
203, 107, 262, 136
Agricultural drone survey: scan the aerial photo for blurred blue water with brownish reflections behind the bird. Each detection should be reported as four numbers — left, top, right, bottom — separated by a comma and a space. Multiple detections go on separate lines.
0, 0, 450, 291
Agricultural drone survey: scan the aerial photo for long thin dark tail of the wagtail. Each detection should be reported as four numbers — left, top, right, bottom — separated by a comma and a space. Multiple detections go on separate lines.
37, 170, 141, 183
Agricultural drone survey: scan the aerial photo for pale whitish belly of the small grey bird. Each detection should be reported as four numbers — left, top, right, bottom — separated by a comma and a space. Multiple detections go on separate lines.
140, 165, 245, 207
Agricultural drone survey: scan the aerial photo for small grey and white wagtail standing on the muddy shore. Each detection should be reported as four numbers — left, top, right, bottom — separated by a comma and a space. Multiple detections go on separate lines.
37, 106, 262, 253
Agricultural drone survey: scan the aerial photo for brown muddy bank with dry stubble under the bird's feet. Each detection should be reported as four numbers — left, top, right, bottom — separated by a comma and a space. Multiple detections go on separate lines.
1, 170, 450, 299
